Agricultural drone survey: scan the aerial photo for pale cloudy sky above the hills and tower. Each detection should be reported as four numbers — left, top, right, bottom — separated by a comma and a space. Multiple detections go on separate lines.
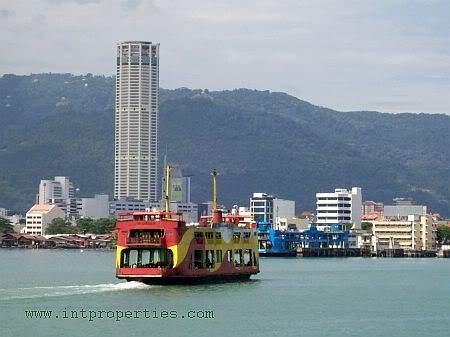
0, 0, 450, 114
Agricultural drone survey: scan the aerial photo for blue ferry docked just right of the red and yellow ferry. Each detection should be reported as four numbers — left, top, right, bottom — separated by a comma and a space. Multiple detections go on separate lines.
257, 222, 301, 257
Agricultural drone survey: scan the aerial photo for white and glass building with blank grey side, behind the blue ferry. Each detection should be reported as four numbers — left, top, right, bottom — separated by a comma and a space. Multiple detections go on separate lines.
250, 193, 295, 229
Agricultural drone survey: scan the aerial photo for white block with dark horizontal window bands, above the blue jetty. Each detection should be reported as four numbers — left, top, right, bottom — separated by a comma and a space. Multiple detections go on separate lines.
316, 187, 362, 229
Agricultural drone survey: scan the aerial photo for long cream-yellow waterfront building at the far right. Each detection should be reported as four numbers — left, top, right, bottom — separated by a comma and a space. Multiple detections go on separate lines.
372, 214, 437, 250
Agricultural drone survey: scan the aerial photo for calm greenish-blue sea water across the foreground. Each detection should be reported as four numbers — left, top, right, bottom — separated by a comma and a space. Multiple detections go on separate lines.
0, 249, 450, 337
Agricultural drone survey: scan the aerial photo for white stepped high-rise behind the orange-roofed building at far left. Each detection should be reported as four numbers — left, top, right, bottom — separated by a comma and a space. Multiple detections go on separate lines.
37, 176, 77, 217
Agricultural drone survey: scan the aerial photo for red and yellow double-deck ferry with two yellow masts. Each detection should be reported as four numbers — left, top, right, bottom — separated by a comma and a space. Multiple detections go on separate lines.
116, 166, 259, 285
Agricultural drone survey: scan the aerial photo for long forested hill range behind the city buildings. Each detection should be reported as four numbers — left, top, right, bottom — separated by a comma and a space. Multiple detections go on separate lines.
0, 74, 450, 216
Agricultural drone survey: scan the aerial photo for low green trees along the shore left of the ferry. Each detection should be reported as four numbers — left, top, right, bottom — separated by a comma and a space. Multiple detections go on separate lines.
47, 218, 116, 234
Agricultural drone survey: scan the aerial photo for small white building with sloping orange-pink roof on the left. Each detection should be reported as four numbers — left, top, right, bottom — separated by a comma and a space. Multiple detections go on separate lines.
24, 204, 65, 235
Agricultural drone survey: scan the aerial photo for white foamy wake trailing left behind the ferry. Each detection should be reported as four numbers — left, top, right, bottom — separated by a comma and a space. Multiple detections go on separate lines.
0, 281, 152, 302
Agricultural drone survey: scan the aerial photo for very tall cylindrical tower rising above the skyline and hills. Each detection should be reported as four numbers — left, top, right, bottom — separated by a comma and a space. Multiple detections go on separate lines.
114, 41, 159, 201
